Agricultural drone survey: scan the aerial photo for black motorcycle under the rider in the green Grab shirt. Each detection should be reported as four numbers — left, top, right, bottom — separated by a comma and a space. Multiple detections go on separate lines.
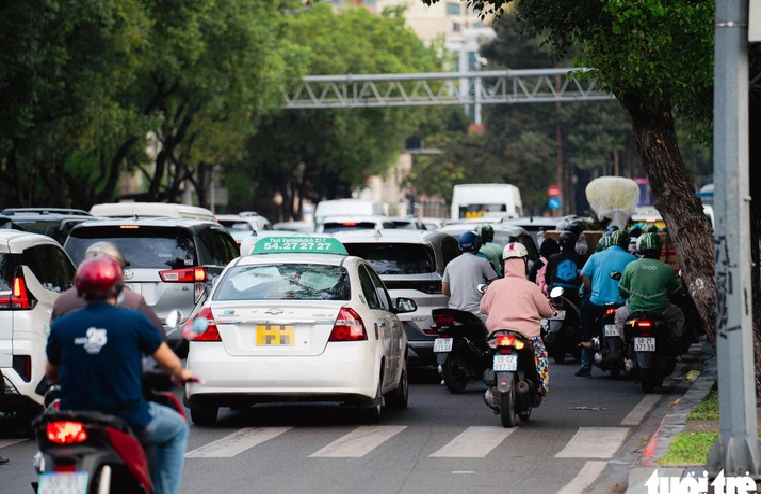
626, 311, 677, 393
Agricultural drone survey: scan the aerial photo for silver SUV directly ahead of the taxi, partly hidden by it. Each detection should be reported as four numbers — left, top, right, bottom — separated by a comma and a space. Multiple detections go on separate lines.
334, 229, 460, 367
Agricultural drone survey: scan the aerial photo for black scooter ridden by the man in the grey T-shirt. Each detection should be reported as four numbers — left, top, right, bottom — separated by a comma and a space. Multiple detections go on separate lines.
433, 309, 489, 394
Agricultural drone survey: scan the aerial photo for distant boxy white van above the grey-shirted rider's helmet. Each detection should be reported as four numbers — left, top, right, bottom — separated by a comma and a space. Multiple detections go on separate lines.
452, 184, 523, 221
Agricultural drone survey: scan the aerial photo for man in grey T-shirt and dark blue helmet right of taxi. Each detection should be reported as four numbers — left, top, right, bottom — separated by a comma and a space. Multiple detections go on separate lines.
441, 232, 499, 320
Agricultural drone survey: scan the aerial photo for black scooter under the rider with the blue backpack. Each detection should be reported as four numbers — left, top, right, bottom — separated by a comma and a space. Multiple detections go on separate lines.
541, 287, 581, 364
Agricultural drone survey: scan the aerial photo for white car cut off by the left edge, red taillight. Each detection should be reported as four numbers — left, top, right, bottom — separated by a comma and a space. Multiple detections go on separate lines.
0, 229, 76, 417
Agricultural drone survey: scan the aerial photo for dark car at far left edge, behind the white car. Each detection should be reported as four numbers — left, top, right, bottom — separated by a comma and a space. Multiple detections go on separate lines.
0, 208, 98, 244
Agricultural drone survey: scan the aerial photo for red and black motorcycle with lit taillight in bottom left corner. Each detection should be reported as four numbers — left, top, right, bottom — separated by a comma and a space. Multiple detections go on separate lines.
32, 315, 200, 494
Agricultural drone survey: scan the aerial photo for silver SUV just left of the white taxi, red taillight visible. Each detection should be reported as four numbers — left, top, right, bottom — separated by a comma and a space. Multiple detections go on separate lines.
64, 218, 239, 356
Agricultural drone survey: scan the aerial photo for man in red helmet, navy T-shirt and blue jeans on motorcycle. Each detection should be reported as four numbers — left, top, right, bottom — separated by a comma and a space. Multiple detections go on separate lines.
46, 256, 193, 494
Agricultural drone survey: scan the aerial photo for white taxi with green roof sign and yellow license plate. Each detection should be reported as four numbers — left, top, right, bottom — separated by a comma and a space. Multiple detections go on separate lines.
183, 236, 417, 425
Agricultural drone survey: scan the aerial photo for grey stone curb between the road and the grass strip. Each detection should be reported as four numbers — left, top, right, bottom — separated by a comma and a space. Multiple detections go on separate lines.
626, 343, 717, 494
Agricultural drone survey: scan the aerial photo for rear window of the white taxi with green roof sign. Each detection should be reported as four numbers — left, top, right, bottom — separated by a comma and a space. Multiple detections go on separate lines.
212, 264, 351, 301
